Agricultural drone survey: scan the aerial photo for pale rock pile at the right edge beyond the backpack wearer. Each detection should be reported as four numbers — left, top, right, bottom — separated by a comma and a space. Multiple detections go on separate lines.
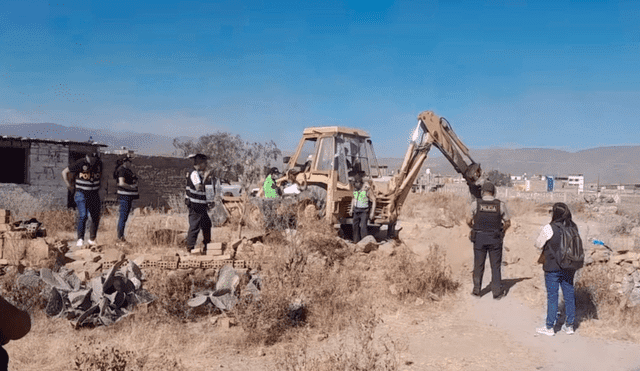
585, 236, 640, 307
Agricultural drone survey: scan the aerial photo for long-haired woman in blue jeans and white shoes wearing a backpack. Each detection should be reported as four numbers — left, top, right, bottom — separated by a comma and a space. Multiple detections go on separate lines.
535, 202, 578, 336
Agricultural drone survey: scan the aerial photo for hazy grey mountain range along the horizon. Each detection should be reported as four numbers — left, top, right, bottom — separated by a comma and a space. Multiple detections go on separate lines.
0, 123, 640, 184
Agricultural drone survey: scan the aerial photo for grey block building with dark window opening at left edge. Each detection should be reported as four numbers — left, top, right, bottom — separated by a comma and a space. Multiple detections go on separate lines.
0, 135, 106, 205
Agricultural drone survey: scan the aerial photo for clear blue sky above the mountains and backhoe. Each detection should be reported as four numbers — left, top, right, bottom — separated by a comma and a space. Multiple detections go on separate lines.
0, 0, 640, 157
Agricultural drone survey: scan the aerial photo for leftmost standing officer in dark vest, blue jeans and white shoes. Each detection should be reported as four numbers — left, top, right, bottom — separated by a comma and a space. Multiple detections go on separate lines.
62, 152, 102, 246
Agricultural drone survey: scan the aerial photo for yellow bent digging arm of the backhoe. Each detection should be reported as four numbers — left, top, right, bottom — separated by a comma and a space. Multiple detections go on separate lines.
389, 111, 482, 221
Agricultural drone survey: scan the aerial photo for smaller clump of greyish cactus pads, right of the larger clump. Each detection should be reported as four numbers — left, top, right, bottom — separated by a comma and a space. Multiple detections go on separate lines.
187, 265, 262, 311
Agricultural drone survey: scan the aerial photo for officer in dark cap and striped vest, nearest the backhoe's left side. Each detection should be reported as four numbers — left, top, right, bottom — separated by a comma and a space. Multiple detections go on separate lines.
185, 153, 212, 253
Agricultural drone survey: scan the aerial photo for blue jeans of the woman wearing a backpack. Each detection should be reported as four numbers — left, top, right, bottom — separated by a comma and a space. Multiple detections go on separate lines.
544, 269, 576, 328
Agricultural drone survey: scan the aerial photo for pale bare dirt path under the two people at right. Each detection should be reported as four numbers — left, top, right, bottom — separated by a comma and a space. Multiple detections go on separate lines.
392, 215, 640, 370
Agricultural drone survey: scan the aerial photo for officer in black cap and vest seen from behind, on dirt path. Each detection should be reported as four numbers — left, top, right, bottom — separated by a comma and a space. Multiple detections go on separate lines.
467, 181, 511, 299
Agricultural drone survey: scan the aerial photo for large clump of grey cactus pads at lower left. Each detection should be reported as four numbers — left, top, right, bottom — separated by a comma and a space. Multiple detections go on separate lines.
17, 260, 154, 328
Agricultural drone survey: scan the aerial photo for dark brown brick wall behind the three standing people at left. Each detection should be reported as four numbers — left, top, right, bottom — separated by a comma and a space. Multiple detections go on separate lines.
102, 154, 193, 208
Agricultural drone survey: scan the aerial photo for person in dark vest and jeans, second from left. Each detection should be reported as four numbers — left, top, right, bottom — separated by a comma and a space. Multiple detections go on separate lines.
113, 156, 140, 243
